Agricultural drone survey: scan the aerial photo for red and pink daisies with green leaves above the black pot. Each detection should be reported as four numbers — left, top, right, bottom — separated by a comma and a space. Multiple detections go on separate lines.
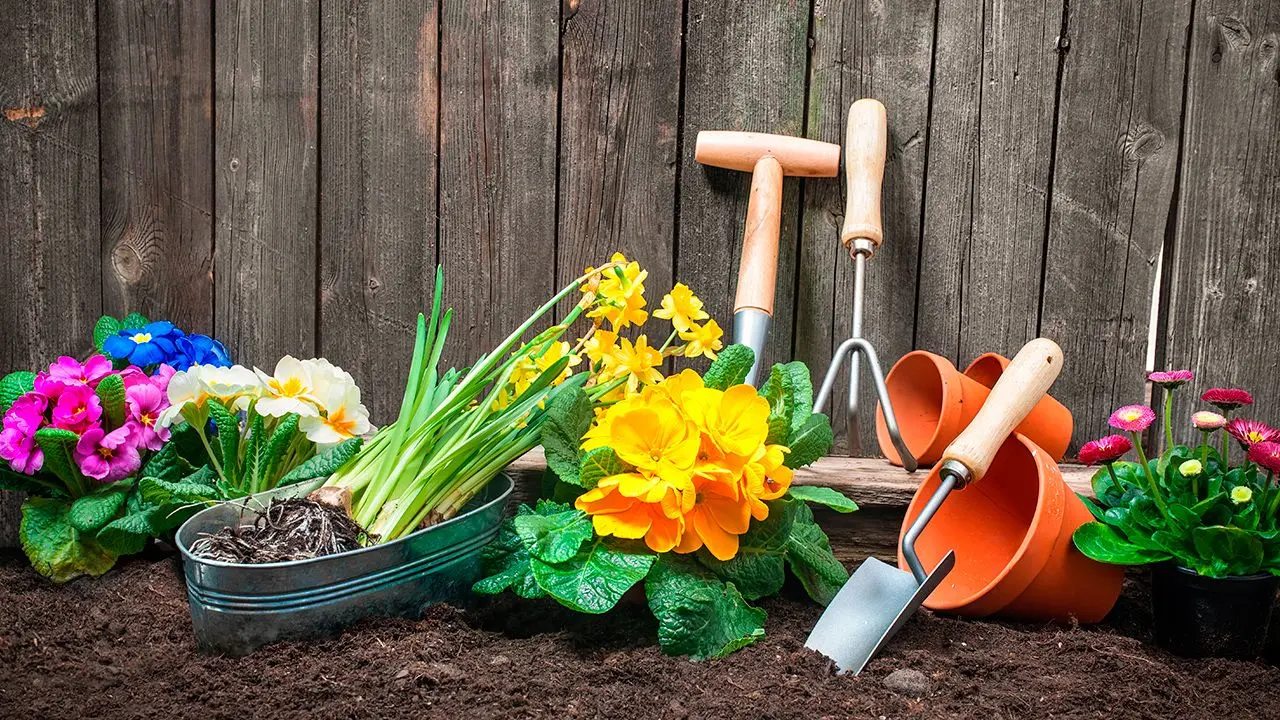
1074, 370, 1280, 578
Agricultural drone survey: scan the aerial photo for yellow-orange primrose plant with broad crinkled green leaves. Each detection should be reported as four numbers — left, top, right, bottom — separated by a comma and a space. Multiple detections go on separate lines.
475, 338, 856, 660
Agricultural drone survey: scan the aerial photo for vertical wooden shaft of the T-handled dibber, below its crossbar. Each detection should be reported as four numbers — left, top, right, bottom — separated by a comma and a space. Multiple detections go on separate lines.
733, 155, 782, 318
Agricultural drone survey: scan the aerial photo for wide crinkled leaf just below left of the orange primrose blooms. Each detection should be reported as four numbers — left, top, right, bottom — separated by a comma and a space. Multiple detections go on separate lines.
529, 538, 655, 614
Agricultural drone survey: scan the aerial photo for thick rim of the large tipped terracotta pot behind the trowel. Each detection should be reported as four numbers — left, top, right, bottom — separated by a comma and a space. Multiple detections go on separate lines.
899, 433, 1065, 615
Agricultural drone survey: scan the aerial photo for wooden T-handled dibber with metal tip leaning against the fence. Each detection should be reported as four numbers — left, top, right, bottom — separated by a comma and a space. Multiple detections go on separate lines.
694, 131, 840, 384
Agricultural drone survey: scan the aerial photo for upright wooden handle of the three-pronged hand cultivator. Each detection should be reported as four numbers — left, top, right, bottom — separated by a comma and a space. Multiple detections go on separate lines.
840, 97, 888, 247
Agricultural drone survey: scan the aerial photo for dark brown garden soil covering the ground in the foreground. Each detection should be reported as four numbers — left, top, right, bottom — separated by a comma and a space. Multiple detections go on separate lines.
0, 551, 1280, 720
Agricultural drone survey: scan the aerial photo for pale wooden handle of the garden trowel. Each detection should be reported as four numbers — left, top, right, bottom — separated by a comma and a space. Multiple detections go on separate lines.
942, 338, 1062, 482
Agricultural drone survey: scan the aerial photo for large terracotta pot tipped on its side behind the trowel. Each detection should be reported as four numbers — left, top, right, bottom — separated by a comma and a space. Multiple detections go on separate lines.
897, 434, 1124, 623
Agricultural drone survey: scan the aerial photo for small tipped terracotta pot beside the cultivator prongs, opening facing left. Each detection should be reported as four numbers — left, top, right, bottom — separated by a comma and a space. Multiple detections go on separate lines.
876, 350, 991, 465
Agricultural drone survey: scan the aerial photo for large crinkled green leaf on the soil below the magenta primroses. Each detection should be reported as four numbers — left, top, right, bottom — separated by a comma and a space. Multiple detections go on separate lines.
18, 497, 116, 583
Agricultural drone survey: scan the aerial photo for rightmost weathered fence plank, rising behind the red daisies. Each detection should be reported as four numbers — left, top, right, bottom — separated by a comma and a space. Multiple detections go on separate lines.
1165, 0, 1280, 434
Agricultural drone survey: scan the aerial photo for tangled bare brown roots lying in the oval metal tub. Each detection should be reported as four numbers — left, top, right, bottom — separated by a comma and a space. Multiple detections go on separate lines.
191, 497, 369, 565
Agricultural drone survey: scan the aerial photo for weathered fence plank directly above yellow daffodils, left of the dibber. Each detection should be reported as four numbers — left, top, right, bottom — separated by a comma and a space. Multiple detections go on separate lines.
557, 0, 684, 304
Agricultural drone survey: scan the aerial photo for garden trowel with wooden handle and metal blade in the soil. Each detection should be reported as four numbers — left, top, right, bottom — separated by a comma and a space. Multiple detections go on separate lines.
805, 338, 1062, 675
